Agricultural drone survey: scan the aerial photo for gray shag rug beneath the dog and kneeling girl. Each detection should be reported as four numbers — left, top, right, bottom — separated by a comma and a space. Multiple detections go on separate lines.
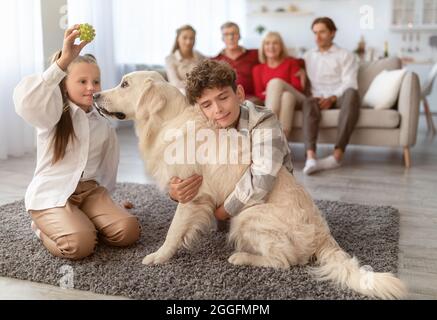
0, 183, 399, 300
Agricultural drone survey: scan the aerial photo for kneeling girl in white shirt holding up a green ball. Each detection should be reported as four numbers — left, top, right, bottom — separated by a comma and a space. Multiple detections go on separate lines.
14, 25, 140, 259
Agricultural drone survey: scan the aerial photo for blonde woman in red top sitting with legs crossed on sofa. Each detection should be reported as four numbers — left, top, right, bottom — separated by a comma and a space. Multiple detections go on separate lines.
252, 32, 306, 138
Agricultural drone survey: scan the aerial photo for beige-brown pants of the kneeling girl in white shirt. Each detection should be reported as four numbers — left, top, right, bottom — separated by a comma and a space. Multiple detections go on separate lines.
30, 181, 141, 259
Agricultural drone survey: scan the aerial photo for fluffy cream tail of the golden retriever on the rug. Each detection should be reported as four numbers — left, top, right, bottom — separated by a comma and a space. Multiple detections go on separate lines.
311, 235, 407, 299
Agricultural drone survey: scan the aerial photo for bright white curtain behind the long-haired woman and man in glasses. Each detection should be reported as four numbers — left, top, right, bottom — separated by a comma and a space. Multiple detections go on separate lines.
113, 0, 246, 65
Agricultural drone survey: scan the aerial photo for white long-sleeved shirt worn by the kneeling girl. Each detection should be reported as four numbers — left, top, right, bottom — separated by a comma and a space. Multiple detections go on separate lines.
13, 63, 119, 211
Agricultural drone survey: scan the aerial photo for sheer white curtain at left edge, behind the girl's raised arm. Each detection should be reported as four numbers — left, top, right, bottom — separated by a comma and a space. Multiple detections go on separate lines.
0, 0, 44, 159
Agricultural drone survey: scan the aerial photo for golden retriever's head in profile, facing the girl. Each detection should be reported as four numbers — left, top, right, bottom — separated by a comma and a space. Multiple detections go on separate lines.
94, 71, 186, 121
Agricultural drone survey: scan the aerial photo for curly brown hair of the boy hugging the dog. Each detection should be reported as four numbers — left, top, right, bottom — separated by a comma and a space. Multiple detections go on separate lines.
185, 60, 237, 105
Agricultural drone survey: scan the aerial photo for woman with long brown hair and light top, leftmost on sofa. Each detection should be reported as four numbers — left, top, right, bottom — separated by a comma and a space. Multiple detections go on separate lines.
165, 25, 205, 93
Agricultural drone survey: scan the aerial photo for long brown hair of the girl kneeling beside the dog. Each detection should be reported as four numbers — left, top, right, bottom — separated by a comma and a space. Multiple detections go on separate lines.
51, 51, 97, 165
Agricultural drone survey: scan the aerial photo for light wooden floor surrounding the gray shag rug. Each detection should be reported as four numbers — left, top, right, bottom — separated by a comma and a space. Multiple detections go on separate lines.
0, 117, 437, 299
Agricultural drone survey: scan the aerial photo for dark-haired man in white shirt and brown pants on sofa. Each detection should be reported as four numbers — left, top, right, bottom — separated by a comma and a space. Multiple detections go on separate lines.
303, 17, 360, 175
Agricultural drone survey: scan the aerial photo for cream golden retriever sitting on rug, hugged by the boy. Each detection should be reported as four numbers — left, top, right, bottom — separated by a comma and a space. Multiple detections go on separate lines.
95, 71, 406, 299
